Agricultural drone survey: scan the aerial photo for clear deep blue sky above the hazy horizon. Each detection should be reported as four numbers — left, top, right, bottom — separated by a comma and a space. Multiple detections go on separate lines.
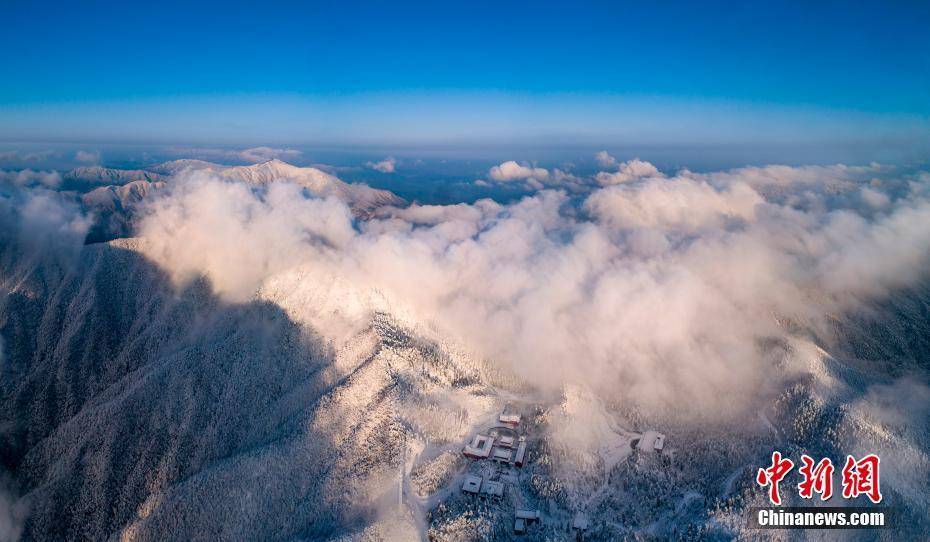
0, 0, 930, 159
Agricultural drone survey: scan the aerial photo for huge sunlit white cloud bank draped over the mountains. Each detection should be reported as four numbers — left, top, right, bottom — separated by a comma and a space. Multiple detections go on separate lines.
132, 161, 930, 416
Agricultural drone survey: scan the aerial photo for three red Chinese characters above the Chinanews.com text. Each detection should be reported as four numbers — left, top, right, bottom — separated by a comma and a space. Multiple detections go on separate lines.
756, 452, 882, 505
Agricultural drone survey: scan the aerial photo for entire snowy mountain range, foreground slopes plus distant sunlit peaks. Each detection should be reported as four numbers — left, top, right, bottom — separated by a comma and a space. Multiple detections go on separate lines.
0, 160, 930, 542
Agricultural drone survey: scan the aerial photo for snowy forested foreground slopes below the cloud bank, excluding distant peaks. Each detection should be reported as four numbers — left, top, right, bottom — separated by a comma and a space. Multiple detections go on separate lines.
0, 224, 930, 540
